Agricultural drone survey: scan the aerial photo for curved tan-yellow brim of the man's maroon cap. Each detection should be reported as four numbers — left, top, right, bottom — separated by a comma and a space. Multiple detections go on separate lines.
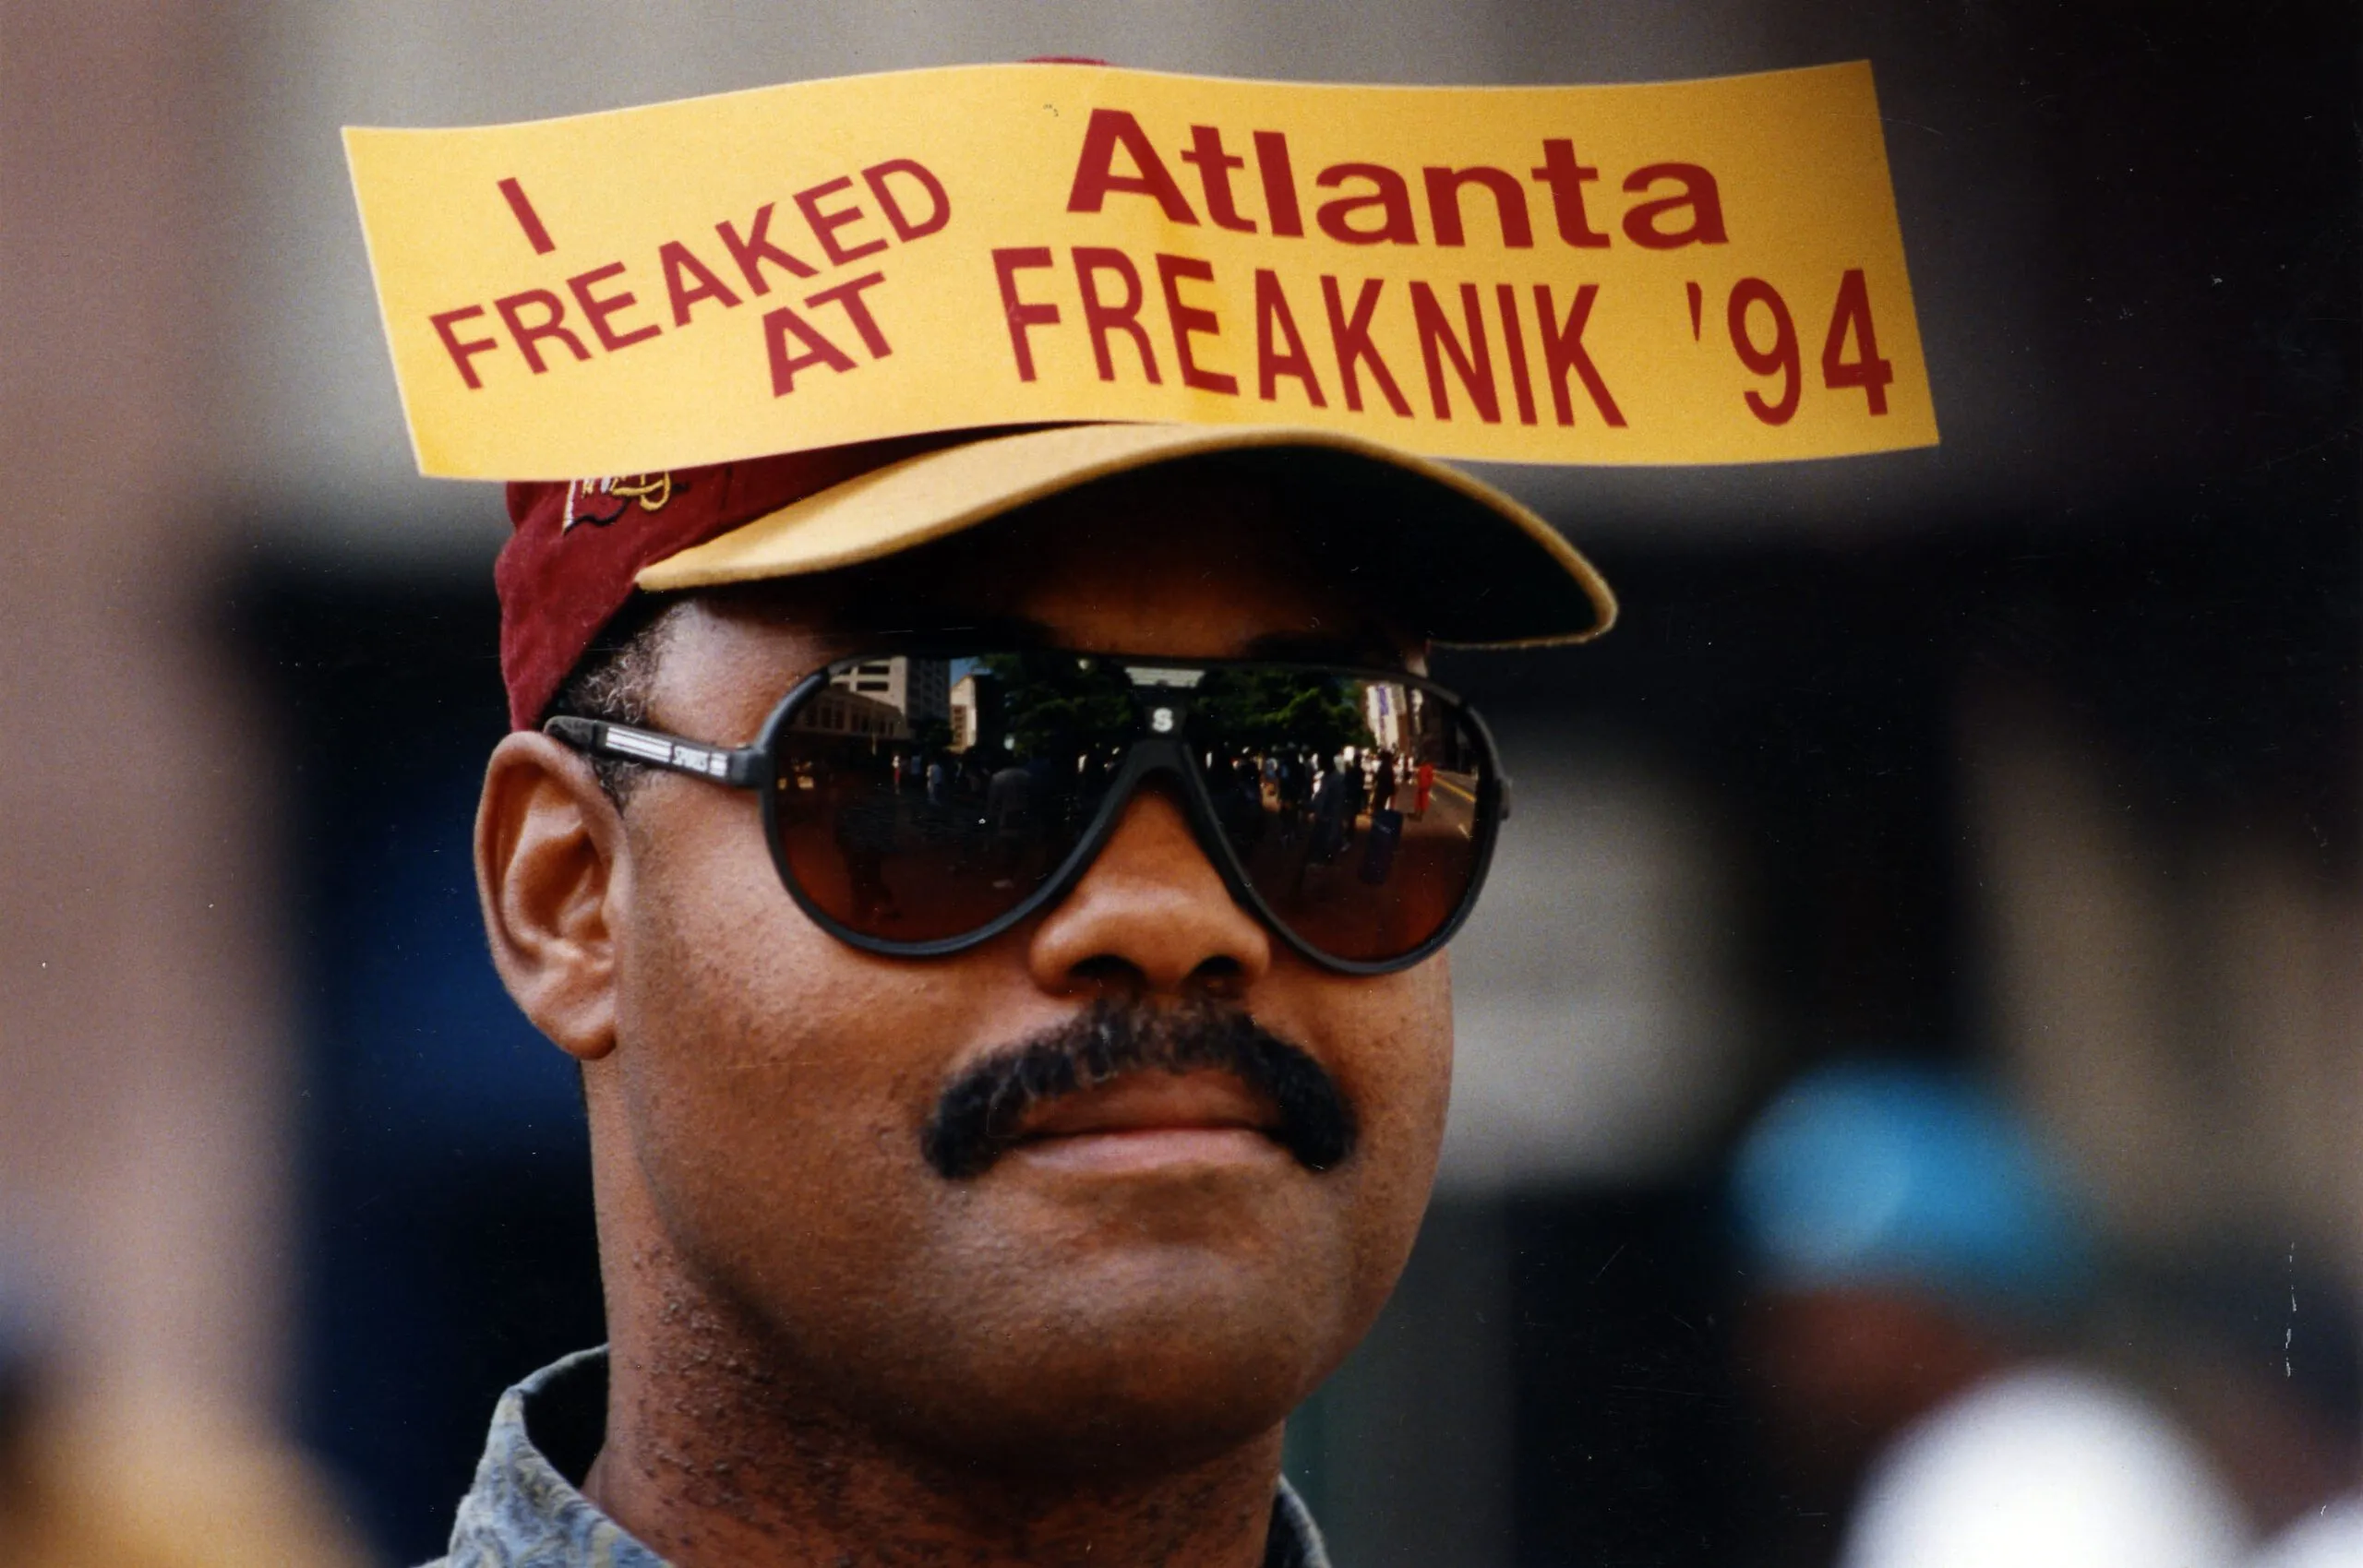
633, 425, 1616, 647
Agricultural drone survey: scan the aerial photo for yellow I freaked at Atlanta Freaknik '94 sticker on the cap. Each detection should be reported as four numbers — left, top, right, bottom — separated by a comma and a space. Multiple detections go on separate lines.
345, 62, 1937, 479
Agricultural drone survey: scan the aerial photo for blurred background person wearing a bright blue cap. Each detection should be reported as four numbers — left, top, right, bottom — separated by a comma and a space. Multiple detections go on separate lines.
1732, 1062, 2248, 1568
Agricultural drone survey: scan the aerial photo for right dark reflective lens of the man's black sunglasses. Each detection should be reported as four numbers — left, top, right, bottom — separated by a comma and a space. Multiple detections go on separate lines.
1191, 666, 1491, 964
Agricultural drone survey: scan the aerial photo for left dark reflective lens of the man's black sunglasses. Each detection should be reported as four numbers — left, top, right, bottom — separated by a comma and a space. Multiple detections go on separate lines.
773, 654, 1136, 944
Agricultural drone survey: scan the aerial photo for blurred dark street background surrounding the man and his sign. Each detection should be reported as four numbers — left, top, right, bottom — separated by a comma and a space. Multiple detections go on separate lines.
0, 0, 2363, 1568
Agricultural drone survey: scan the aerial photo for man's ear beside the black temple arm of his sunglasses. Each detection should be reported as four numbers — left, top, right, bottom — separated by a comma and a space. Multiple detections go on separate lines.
475, 732, 631, 1060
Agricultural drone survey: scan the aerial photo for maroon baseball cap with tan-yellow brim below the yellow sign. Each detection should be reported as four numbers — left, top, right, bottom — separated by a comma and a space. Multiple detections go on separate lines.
494, 423, 1616, 730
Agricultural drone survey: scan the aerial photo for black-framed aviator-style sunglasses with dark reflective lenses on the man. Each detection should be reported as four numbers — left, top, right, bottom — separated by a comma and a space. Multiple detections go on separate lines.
544, 650, 1510, 976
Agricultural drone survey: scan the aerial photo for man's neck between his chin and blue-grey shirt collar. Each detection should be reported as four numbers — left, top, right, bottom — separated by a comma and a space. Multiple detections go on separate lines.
583, 1250, 1281, 1568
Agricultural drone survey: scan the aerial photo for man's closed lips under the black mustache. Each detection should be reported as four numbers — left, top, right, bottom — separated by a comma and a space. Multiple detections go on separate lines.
1012, 1070, 1288, 1174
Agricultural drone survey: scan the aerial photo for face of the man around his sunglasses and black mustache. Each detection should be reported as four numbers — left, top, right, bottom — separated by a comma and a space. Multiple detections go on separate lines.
541, 474, 1451, 1471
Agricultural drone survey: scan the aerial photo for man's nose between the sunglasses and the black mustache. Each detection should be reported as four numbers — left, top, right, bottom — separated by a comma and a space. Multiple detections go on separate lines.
1028, 779, 1271, 997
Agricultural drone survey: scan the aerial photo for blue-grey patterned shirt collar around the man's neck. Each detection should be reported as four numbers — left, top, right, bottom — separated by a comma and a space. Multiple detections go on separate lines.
430, 1346, 1330, 1568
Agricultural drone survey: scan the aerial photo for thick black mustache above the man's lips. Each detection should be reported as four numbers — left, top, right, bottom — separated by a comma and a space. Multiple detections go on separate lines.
919, 1001, 1356, 1180
